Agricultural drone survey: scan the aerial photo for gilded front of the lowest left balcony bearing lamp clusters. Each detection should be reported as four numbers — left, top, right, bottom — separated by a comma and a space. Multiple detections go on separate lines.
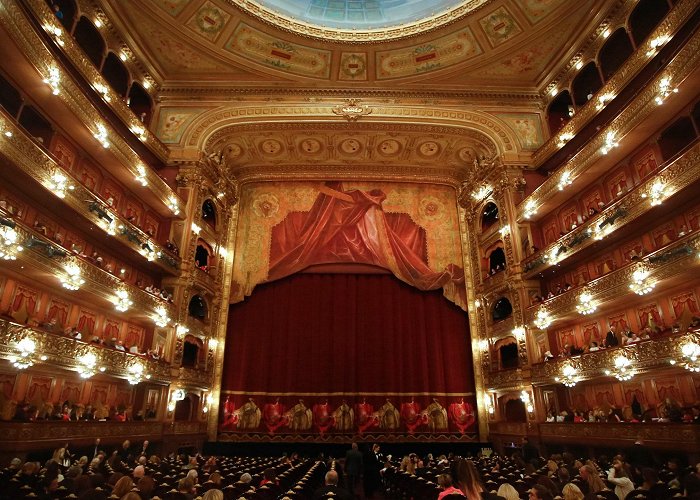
0, 319, 172, 383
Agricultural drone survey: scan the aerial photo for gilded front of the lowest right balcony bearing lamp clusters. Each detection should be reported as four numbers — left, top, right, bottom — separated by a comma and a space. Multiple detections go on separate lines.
531, 332, 700, 385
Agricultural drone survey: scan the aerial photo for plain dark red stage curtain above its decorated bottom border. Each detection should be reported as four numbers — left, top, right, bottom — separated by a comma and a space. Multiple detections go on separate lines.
222, 274, 474, 396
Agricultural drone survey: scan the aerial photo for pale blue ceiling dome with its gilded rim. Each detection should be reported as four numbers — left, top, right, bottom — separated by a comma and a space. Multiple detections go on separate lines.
229, 0, 491, 42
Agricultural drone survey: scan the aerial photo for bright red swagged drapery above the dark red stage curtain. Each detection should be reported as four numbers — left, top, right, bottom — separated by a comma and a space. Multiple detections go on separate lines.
268, 182, 466, 310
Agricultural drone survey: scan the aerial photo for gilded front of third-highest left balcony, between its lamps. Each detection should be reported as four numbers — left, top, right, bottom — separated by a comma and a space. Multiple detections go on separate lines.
0, 110, 175, 273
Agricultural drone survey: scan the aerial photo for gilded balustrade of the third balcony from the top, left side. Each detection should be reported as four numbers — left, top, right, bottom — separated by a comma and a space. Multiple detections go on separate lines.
0, 109, 179, 273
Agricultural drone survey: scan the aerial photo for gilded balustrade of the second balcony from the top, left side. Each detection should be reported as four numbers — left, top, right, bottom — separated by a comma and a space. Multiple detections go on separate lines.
0, 2, 184, 217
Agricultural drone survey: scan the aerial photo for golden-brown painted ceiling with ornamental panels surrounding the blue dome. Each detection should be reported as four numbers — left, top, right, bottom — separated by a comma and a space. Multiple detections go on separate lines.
104, 0, 614, 91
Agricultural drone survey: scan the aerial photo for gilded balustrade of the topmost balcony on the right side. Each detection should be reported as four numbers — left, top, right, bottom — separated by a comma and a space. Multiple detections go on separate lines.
532, 0, 697, 166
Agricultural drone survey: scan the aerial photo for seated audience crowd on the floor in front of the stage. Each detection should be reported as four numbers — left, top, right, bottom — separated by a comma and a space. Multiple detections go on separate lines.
0, 438, 700, 500
